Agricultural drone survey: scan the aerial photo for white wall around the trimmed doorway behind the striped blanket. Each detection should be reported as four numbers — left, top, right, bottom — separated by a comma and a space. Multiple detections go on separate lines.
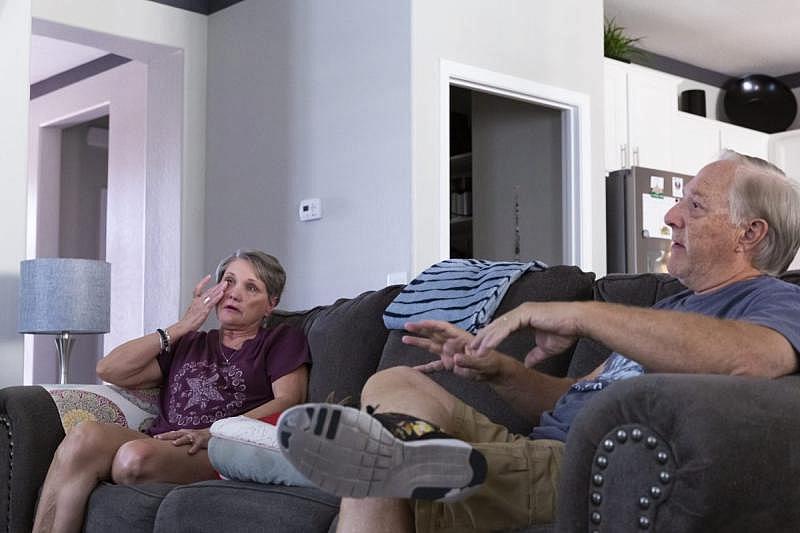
411, 0, 606, 274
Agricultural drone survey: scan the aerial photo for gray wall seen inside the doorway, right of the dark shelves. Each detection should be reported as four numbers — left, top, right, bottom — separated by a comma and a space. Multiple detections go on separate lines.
472, 92, 563, 265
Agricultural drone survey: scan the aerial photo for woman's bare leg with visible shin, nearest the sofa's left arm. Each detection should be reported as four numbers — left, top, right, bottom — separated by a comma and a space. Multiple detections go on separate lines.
33, 422, 148, 533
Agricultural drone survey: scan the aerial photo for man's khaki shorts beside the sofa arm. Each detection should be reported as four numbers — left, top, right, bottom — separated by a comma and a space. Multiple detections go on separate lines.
412, 400, 564, 533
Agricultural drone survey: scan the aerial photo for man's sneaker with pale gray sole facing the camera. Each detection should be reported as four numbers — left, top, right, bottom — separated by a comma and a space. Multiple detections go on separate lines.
278, 403, 486, 501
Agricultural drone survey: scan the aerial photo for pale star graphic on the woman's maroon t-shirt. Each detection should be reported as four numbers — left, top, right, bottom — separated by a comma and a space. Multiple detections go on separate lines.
167, 361, 247, 427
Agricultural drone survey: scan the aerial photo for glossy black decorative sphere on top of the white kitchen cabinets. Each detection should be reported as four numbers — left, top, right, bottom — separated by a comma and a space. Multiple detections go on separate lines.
724, 74, 797, 133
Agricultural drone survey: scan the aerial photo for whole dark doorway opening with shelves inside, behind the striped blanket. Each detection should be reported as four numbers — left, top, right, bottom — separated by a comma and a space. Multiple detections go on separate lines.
450, 85, 565, 264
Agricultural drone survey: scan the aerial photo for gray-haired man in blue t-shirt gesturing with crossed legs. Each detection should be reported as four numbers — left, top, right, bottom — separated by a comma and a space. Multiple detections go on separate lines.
279, 152, 800, 532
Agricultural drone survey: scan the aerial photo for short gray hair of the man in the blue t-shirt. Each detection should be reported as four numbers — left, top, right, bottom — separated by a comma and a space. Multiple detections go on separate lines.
720, 150, 800, 276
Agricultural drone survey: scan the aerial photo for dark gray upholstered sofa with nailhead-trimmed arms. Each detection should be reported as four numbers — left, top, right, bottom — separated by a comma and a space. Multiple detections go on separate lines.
0, 266, 800, 533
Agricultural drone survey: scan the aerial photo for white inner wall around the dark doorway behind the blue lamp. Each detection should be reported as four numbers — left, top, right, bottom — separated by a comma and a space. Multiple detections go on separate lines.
25, 61, 148, 383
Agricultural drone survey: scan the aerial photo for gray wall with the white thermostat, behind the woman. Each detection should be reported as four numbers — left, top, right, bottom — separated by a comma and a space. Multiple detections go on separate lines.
205, 0, 411, 309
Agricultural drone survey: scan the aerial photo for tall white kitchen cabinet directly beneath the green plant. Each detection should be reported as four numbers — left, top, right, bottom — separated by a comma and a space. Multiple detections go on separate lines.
604, 59, 679, 171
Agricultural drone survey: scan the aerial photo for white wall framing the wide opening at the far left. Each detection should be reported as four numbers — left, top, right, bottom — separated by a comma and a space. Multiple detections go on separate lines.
0, 0, 208, 385
